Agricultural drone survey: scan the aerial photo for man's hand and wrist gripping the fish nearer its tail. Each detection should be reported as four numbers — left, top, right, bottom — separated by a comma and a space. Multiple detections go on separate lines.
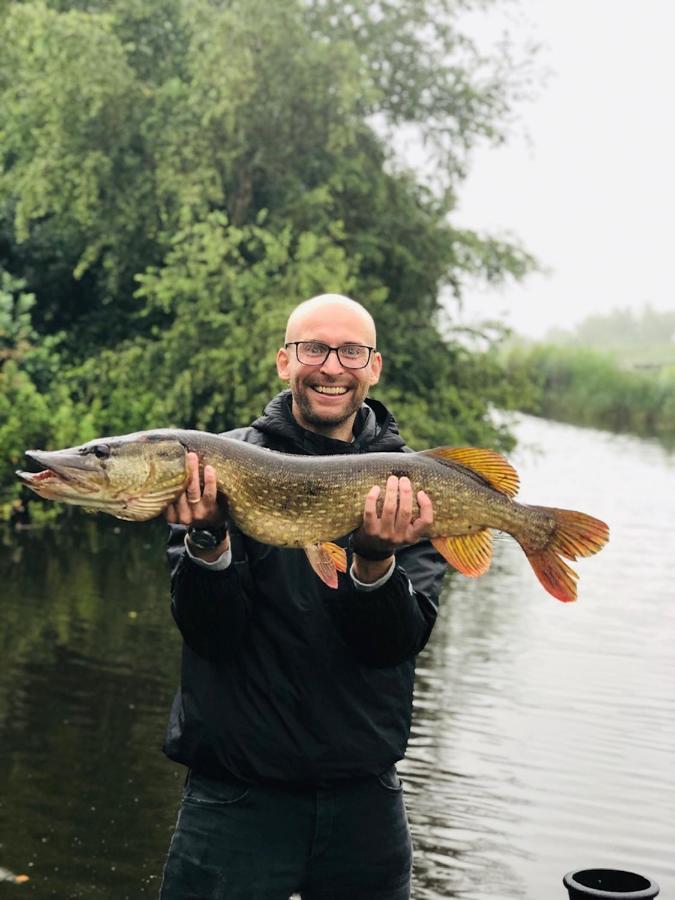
352, 475, 434, 582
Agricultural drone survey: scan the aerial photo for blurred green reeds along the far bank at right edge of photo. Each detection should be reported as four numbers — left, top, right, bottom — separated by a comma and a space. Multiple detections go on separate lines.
507, 344, 675, 444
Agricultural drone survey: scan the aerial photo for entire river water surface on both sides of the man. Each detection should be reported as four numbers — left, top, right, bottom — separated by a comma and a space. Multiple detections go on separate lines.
0, 418, 675, 900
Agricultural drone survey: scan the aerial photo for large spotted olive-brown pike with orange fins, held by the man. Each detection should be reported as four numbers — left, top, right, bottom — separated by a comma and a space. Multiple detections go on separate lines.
17, 429, 609, 601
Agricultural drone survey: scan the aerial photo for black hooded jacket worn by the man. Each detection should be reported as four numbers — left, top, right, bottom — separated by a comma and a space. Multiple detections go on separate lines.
164, 391, 446, 784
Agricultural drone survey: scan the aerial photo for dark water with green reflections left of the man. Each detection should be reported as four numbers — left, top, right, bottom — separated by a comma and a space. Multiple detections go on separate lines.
0, 515, 181, 898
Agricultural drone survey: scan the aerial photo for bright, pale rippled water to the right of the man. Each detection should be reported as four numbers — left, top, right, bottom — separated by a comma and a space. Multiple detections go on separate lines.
403, 419, 675, 900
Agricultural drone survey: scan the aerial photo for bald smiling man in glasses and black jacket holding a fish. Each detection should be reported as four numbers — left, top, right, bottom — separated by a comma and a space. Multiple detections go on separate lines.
161, 294, 446, 900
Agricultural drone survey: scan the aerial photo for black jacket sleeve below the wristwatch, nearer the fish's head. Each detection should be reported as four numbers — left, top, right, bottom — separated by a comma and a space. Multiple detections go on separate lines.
167, 525, 250, 663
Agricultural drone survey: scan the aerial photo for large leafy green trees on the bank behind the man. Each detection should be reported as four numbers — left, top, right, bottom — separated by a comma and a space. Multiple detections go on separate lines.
0, 0, 532, 518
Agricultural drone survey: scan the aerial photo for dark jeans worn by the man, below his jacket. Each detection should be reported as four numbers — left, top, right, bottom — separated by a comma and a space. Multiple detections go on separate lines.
160, 767, 412, 900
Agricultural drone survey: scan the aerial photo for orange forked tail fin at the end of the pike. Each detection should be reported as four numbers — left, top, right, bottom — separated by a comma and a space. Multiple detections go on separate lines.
523, 506, 609, 603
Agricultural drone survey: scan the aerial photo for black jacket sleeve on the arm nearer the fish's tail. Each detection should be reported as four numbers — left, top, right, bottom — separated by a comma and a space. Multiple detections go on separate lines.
326, 541, 447, 668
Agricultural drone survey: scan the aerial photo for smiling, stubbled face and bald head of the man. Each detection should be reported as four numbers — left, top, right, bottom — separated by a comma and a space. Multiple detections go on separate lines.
277, 304, 382, 440
